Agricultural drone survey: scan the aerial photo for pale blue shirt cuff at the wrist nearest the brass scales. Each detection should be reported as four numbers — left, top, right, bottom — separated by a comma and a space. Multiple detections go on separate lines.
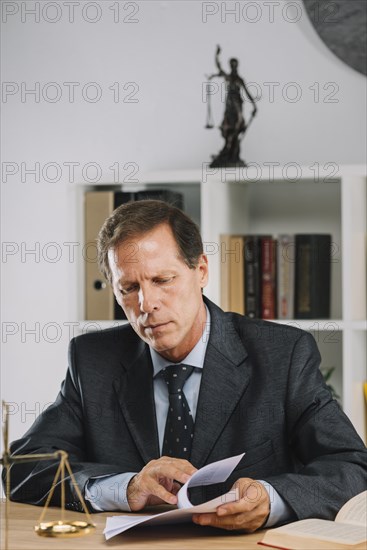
84, 472, 136, 512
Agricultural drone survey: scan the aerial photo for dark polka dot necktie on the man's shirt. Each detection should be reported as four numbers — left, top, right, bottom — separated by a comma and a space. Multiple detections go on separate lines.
161, 365, 194, 460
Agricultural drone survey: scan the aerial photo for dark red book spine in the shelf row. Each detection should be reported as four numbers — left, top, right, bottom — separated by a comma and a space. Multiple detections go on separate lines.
261, 237, 276, 319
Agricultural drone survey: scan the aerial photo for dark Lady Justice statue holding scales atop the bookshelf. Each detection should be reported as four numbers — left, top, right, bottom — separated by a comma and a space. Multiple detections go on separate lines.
206, 46, 257, 168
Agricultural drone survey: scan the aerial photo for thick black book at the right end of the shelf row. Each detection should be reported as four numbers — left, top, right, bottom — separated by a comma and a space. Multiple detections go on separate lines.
295, 234, 331, 319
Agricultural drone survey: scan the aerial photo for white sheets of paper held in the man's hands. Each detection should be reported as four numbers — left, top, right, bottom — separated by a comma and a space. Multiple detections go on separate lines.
103, 453, 245, 540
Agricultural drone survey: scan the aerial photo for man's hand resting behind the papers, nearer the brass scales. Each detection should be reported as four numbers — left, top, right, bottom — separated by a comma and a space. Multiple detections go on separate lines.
127, 456, 196, 512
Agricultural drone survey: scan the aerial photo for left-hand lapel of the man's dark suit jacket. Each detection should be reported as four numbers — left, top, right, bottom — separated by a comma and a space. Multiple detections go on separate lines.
114, 341, 159, 463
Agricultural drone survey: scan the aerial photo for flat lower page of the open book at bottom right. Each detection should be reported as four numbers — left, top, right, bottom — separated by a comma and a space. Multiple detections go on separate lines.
277, 519, 366, 544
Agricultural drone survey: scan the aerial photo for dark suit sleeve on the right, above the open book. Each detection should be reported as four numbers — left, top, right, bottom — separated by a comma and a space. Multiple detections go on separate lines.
266, 333, 367, 519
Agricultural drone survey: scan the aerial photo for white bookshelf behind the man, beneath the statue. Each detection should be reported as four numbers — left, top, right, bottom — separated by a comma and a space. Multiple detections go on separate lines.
81, 166, 367, 439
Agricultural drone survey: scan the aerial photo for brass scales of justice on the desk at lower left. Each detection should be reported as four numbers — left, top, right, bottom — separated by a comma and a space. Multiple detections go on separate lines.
0, 401, 96, 550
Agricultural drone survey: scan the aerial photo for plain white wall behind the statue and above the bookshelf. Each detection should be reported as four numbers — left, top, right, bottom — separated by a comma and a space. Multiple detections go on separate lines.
1, 0, 366, 439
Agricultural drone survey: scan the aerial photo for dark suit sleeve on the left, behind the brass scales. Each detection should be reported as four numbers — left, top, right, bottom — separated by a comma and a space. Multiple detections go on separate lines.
3, 340, 120, 511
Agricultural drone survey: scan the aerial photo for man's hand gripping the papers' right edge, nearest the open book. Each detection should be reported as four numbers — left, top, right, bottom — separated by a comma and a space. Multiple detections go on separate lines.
192, 477, 270, 533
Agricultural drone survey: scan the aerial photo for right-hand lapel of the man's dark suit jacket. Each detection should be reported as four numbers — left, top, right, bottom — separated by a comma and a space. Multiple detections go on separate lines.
191, 300, 250, 468
